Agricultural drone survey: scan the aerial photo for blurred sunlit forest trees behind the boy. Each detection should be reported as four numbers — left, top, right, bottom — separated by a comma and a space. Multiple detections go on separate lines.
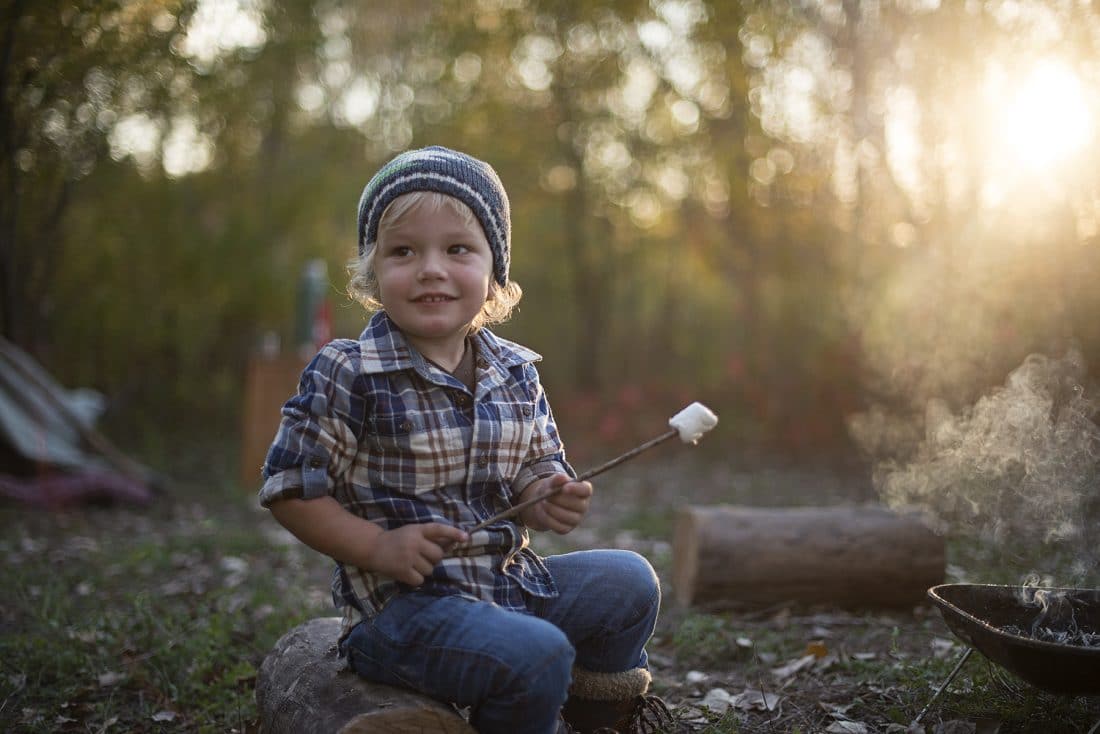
0, 0, 1100, 482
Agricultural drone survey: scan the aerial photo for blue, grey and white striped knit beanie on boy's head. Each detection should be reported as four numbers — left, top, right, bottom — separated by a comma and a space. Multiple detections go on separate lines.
359, 145, 512, 286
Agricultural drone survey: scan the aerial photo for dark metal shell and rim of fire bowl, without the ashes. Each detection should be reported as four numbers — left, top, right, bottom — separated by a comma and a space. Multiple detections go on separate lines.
928, 583, 1100, 695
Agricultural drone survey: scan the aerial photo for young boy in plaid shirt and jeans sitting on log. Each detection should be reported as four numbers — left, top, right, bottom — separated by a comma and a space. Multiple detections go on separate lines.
260, 147, 671, 734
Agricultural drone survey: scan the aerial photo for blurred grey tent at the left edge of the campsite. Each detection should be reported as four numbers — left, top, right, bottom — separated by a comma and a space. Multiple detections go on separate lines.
0, 338, 153, 507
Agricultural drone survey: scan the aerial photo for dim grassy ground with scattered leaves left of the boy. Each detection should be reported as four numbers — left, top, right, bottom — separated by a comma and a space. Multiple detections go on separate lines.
0, 481, 332, 732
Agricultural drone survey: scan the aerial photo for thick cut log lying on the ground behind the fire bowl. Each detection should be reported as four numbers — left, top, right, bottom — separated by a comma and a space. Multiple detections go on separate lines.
671, 505, 946, 609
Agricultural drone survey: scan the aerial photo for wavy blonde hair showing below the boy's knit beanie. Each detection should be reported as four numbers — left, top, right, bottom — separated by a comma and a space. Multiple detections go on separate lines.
348, 191, 524, 331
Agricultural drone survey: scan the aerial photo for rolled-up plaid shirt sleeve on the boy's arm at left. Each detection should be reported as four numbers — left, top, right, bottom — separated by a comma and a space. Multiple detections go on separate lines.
260, 340, 365, 507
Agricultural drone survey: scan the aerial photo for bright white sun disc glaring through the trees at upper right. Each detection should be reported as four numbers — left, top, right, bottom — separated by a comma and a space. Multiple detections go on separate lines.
991, 61, 1092, 171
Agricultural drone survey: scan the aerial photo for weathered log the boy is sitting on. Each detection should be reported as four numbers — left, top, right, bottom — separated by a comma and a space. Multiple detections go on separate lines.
256, 617, 474, 734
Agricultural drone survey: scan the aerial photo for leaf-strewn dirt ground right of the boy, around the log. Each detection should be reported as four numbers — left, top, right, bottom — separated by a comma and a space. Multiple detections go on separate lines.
535, 459, 1100, 734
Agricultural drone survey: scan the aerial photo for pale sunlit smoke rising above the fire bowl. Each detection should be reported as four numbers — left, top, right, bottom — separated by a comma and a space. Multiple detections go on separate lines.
850, 349, 1100, 574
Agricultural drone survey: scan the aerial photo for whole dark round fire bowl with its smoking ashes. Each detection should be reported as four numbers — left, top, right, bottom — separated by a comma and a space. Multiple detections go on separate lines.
928, 583, 1100, 695
